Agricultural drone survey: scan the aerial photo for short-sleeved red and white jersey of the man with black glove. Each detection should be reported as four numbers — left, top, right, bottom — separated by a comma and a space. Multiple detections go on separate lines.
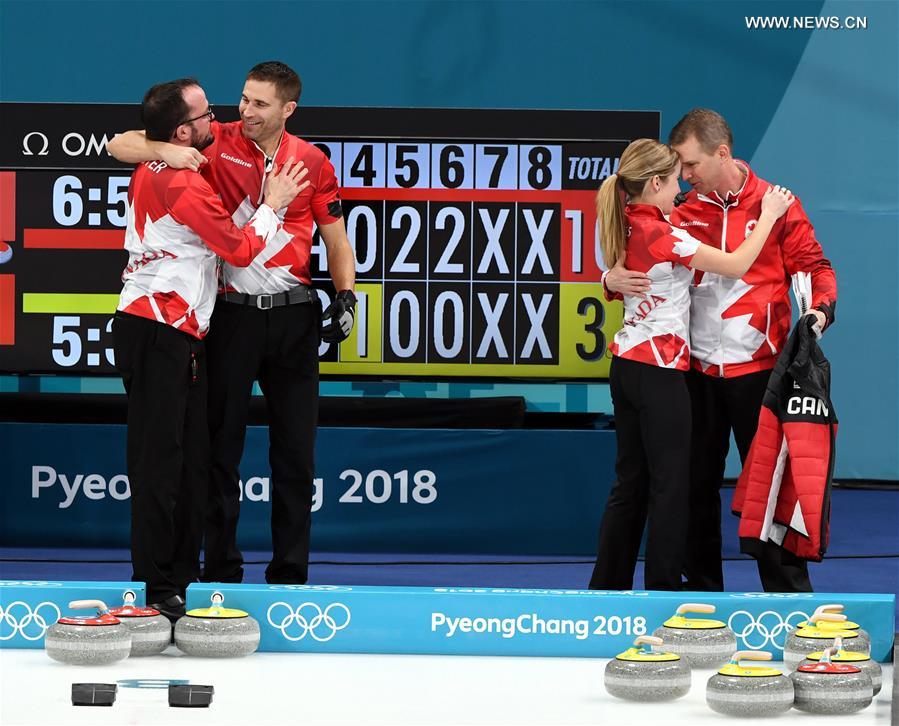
203, 121, 342, 295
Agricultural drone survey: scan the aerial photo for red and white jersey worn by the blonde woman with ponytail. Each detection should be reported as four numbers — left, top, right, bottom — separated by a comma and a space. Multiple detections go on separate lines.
611, 204, 701, 371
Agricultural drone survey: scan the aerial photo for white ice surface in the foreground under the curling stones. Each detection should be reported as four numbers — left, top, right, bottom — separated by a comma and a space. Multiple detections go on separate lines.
0, 646, 893, 726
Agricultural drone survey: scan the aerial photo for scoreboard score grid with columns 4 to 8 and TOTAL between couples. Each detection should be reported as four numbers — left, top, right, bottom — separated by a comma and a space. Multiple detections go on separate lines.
310, 138, 627, 378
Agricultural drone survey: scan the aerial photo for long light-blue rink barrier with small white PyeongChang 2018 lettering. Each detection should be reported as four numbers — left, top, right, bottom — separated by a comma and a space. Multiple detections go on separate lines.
187, 583, 895, 660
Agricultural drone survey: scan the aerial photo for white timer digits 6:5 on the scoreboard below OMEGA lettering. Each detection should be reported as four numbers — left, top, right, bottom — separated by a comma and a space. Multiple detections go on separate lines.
53, 174, 131, 227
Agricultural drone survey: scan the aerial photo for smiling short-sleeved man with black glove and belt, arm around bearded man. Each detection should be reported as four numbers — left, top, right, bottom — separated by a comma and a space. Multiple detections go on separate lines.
108, 61, 355, 584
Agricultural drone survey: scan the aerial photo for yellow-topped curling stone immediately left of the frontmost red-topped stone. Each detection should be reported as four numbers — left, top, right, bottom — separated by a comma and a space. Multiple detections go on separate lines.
705, 650, 793, 717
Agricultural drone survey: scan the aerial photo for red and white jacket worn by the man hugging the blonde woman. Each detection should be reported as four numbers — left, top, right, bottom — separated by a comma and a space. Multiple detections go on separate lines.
672, 162, 837, 378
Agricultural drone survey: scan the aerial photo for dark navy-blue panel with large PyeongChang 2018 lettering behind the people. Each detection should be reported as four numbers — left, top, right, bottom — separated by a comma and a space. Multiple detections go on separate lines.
0, 423, 615, 555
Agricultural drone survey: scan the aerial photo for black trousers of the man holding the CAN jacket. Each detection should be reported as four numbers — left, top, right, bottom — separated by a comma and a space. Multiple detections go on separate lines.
684, 370, 812, 592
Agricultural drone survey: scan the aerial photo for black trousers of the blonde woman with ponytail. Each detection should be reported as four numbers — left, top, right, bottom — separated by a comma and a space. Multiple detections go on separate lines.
589, 356, 691, 590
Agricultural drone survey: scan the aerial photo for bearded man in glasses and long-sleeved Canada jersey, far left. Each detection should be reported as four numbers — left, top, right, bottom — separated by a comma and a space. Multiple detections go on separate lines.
113, 78, 306, 619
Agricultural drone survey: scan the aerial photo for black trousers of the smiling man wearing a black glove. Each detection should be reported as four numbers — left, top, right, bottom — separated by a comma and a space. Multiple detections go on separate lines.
203, 299, 321, 584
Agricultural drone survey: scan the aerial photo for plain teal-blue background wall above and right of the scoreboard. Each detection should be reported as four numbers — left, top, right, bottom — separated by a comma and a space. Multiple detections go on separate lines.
0, 0, 899, 480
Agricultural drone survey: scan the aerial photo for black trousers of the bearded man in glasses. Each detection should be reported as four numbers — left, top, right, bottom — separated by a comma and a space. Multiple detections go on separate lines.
112, 312, 209, 603
